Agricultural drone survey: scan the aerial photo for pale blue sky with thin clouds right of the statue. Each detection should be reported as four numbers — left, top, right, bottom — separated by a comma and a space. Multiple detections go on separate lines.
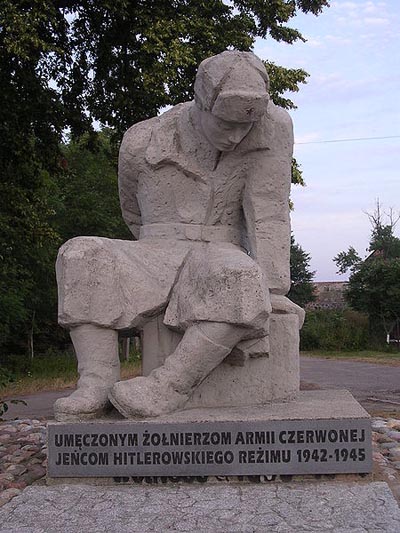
254, 0, 400, 281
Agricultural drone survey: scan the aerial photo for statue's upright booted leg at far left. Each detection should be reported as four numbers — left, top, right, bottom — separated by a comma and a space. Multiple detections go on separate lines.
54, 324, 120, 422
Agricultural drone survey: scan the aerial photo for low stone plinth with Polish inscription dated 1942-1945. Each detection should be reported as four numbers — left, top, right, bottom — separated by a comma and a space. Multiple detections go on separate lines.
48, 390, 372, 482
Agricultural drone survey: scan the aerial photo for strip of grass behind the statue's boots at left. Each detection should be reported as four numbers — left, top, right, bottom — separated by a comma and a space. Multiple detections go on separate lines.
0, 354, 141, 399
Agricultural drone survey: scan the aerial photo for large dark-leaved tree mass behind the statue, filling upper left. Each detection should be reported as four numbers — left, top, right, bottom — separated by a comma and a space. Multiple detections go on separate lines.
0, 0, 328, 358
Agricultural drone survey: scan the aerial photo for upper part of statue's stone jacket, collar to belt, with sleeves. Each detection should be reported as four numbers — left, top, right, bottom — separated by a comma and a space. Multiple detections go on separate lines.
119, 102, 293, 294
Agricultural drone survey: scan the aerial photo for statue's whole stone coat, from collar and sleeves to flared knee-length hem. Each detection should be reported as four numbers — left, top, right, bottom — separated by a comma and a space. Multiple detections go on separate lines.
57, 98, 293, 336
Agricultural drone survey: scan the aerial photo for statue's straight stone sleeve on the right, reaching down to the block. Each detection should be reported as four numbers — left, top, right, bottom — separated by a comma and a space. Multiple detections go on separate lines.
243, 106, 293, 295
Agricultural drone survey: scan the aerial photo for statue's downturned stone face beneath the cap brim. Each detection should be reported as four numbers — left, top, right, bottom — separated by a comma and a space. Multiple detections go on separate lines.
201, 111, 253, 152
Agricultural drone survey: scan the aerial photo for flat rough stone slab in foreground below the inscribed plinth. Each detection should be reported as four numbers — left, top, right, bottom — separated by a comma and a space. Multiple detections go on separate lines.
0, 482, 400, 533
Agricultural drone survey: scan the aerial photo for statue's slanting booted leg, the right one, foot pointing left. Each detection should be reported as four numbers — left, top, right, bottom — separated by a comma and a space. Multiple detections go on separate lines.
109, 322, 248, 418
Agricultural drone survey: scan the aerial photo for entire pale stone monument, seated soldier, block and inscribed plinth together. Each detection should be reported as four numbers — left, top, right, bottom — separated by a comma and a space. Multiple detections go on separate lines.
49, 51, 371, 477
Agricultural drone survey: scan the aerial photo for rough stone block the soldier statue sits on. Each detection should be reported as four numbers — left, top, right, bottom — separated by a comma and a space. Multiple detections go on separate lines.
142, 314, 300, 409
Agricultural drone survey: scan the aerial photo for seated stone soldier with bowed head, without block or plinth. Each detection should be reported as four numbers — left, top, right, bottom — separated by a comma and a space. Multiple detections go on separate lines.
55, 51, 304, 421
